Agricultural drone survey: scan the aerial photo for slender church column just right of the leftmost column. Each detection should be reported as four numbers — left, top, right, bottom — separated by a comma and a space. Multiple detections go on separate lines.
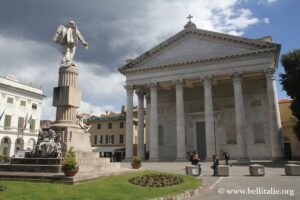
135, 89, 145, 159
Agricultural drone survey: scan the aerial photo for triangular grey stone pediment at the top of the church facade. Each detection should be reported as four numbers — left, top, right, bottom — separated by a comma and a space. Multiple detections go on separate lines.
120, 29, 280, 72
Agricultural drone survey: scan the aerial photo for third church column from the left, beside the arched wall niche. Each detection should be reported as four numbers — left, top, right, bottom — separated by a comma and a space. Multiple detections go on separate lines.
149, 83, 159, 161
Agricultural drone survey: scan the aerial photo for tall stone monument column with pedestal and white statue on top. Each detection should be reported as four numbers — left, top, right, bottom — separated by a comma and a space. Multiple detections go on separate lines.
51, 21, 92, 153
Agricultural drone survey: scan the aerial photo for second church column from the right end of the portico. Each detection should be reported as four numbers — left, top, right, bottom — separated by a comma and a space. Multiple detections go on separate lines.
232, 72, 249, 162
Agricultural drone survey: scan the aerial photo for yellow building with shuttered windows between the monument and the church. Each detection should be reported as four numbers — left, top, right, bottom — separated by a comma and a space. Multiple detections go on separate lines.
88, 111, 143, 161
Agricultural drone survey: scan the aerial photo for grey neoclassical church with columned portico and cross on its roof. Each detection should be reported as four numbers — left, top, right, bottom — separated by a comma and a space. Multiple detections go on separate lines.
119, 21, 283, 161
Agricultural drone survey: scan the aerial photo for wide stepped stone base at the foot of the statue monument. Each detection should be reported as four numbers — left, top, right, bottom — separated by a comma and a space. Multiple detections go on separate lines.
0, 152, 129, 184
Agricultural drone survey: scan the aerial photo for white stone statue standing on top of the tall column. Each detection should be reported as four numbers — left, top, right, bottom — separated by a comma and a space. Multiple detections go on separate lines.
53, 21, 89, 65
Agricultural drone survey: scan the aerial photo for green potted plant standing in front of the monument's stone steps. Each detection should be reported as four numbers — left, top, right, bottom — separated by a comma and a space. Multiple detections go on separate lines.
62, 147, 79, 176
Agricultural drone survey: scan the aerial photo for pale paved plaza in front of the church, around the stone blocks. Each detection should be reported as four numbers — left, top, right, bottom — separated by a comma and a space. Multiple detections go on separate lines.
121, 161, 300, 200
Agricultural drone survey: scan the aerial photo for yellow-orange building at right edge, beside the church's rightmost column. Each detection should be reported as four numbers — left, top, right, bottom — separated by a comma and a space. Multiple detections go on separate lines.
279, 100, 300, 160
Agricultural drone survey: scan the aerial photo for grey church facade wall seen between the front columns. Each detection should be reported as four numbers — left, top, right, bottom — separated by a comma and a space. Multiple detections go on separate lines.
158, 79, 271, 160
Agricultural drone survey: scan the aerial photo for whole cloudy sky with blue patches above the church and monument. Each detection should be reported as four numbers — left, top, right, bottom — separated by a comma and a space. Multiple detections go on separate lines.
0, 0, 300, 119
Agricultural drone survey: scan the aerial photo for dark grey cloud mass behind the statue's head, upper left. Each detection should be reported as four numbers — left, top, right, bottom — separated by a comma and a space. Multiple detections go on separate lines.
0, 0, 149, 73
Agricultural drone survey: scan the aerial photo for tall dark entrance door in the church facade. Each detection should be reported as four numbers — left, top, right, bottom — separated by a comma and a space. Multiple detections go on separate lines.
196, 122, 206, 160
